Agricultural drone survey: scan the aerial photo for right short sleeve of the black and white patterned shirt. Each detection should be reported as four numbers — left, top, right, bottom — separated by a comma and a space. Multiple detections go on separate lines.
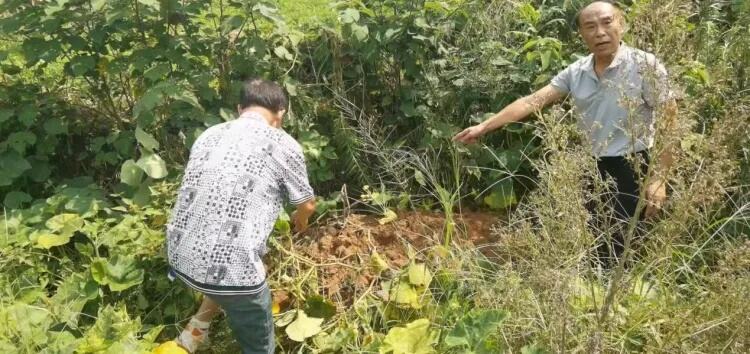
280, 144, 315, 205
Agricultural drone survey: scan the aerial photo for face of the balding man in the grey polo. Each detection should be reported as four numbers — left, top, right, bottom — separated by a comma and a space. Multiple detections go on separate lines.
578, 2, 623, 56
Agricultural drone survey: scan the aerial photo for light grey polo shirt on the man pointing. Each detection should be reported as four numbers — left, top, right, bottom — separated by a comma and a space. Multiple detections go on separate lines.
551, 44, 671, 157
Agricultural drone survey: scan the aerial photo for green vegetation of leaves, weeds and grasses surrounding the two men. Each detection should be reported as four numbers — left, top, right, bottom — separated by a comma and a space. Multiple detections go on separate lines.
0, 0, 750, 353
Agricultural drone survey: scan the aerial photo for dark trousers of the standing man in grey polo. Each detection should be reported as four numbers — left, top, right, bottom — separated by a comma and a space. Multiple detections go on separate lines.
589, 151, 649, 265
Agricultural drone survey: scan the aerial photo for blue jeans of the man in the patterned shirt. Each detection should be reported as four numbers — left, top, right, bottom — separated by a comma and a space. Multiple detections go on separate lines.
206, 286, 274, 354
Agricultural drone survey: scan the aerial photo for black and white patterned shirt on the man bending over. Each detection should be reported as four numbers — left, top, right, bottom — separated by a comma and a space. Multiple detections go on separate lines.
167, 113, 314, 295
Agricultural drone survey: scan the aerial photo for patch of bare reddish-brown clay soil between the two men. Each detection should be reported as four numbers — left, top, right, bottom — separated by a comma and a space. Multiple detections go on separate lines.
275, 212, 500, 303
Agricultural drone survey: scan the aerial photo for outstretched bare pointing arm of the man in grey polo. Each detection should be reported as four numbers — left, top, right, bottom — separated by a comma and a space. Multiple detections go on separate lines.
453, 85, 565, 144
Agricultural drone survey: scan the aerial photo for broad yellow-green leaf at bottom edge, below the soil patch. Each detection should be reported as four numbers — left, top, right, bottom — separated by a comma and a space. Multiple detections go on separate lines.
380, 318, 438, 354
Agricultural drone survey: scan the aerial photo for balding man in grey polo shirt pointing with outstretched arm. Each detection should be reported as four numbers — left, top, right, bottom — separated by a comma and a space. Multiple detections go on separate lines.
454, 1, 677, 257
